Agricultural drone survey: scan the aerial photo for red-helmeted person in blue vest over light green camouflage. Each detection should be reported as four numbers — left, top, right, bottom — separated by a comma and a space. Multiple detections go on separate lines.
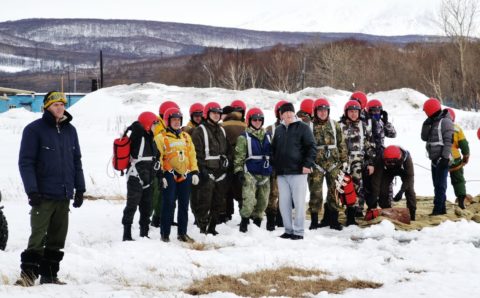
234, 108, 272, 233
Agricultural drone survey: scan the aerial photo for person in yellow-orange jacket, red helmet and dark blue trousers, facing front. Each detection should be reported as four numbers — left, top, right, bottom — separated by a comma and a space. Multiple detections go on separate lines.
155, 108, 199, 243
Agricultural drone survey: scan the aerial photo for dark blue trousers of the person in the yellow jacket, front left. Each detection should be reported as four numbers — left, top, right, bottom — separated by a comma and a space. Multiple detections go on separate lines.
160, 172, 192, 236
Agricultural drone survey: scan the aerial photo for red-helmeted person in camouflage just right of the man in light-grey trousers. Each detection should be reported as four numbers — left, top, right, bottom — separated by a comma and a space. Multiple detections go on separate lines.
308, 98, 348, 230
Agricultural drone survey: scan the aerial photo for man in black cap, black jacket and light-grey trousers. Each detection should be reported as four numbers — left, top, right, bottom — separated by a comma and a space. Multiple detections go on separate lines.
272, 103, 317, 240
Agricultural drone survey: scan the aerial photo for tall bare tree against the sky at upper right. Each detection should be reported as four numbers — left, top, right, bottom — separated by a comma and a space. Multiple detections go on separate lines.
439, 0, 479, 104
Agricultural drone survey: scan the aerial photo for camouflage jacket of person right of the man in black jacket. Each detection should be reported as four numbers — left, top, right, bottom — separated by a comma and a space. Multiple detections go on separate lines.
313, 119, 348, 165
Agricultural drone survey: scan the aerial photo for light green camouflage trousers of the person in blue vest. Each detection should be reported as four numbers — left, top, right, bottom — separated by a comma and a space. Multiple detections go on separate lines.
240, 172, 270, 219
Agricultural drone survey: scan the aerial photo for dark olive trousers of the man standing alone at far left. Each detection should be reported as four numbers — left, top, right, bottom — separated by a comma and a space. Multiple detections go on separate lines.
27, 199, 70, 255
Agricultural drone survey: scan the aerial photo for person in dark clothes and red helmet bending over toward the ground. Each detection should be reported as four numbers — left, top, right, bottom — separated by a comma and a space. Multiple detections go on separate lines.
367, 145, 417, 220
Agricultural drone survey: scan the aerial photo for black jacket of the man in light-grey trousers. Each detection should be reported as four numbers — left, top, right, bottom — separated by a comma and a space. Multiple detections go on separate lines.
272, 119, 317, 175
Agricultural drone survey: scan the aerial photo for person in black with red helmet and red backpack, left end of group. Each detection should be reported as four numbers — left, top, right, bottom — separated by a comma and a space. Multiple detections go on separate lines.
122, 112, 159, 241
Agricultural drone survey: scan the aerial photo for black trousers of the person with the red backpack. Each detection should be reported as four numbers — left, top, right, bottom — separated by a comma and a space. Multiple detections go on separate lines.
122, 176, 152, 226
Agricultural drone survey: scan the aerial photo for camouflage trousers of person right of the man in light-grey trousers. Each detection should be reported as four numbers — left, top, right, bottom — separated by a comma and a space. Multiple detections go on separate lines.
308, 162, 340, 213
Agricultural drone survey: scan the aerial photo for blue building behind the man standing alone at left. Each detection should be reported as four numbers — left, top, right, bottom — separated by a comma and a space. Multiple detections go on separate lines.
0, 93, 85, 113
